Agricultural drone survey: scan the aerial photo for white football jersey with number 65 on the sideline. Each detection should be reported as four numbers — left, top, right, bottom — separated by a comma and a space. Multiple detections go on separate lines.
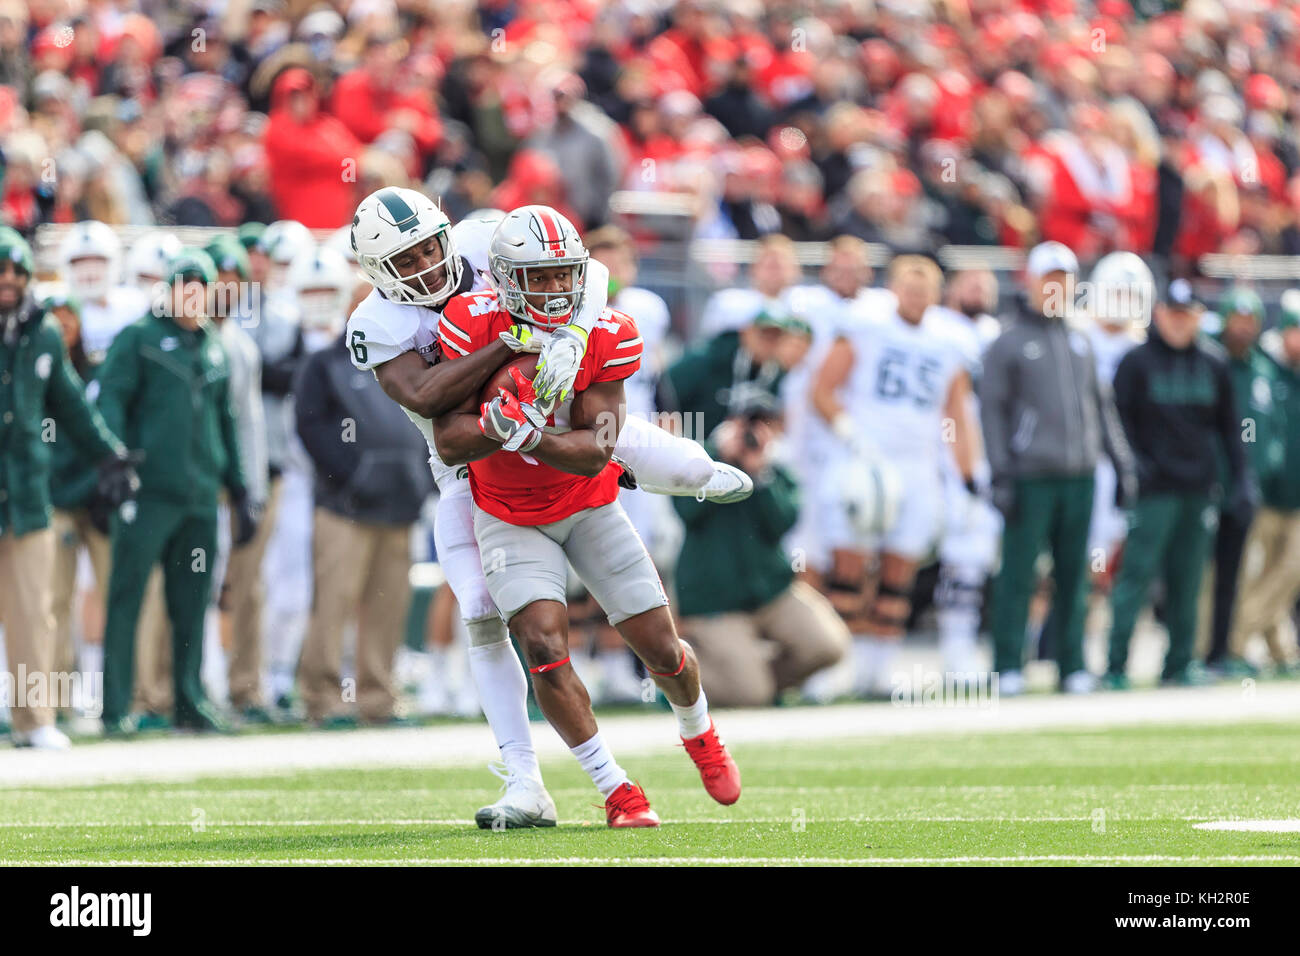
844, 311, 978, 475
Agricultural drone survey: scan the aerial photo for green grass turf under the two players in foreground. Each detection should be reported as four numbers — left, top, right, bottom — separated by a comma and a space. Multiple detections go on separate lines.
0, 723, 1300, 865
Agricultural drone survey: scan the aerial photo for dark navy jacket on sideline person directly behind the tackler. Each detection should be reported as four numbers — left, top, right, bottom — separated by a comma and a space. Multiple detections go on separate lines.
294, 336, 433, 524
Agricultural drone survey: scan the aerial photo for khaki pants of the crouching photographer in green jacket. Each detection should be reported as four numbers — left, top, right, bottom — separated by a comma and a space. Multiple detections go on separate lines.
681, 581, 849, 708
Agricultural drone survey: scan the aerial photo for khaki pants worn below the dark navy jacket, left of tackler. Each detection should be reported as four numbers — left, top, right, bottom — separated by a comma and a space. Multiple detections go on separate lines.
298, 507, 411, 721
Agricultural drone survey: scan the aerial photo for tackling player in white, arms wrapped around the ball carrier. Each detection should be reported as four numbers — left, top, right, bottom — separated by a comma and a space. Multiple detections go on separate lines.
347, 186, 753, 827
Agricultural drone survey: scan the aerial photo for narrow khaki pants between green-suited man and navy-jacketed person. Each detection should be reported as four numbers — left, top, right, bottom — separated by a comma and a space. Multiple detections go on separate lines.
221, 480, 280, 709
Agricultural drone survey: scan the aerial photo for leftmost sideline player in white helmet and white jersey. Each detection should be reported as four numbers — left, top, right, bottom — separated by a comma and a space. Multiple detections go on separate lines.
59, 220, 151, 365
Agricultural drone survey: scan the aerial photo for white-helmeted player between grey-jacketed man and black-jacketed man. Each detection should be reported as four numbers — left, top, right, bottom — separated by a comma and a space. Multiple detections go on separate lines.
1087, 252, 1156, 568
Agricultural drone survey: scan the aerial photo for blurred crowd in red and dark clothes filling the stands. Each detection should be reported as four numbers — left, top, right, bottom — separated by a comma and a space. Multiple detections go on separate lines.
0, 0, 1300, 267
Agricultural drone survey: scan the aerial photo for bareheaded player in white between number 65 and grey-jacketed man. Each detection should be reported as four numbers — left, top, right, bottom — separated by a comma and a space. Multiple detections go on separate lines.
931, 269, 1002, 680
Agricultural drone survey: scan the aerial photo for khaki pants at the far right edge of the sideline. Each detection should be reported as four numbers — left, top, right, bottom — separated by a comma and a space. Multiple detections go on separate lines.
1230, 507, 1300, 663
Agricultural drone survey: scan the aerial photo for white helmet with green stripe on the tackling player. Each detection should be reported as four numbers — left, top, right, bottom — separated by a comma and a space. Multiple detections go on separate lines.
352, 186, 462, 306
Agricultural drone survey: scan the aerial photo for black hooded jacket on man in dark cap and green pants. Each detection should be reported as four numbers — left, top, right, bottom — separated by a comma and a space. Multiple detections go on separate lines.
1114, 325, 1245, 497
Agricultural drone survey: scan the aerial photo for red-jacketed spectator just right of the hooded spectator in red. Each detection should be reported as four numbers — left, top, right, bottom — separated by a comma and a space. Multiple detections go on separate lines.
330, 36, 442, 173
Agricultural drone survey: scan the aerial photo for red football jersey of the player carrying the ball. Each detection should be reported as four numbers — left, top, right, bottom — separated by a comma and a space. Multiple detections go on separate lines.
438, 291, 641, 525
